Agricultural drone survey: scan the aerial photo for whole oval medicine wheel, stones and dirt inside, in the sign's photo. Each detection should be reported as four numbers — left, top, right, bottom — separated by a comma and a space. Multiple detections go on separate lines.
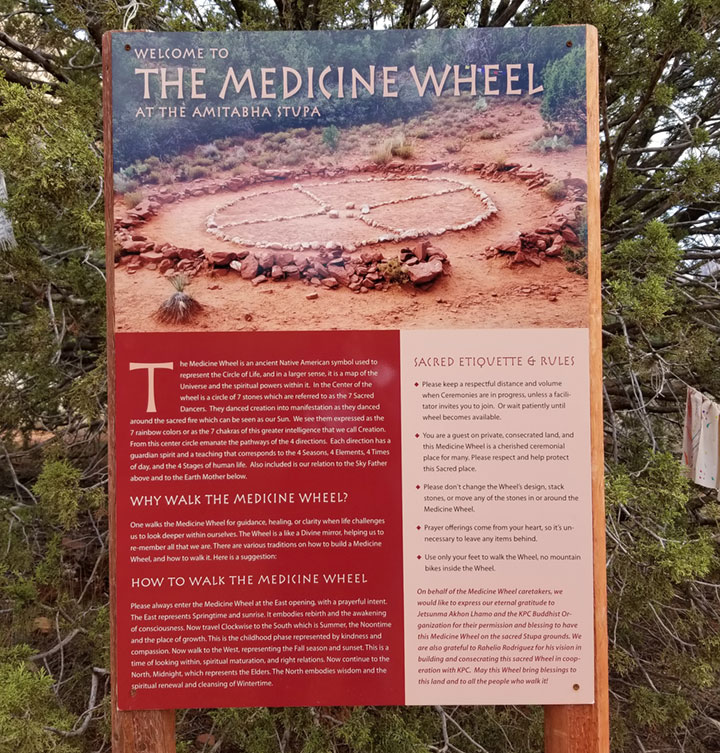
205, 175, 497, 252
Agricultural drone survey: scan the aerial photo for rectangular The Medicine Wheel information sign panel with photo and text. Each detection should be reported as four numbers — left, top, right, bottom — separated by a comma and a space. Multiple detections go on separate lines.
105, 27, 597, 709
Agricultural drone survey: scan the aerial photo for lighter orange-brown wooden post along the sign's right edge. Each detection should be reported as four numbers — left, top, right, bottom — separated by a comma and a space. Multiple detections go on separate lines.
545, 26, 610, 753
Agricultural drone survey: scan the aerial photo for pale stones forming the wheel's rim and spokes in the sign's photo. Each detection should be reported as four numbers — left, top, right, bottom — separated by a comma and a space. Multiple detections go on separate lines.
205, 175, 497, 251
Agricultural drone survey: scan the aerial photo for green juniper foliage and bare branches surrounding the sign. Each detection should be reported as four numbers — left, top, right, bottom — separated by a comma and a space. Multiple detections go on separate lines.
0, 0, 720, 753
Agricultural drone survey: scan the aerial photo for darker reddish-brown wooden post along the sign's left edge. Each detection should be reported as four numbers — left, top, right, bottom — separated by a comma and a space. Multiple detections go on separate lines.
103, 32, 175, 753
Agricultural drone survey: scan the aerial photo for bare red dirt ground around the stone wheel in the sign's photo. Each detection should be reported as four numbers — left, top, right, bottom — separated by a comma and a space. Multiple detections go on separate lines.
115, 100, 588, 332
